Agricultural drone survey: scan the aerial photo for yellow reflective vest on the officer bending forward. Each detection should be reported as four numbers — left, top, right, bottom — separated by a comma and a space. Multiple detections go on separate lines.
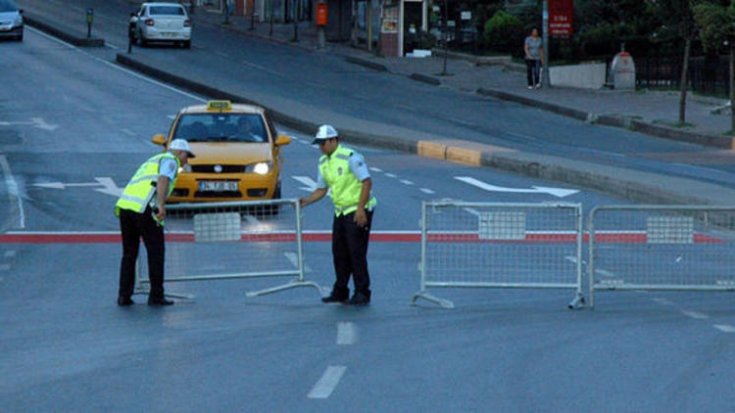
115, 152, 181, 215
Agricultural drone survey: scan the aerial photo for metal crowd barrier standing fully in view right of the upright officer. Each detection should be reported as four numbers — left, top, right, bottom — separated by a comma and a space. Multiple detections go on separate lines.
411, 201, 584, 308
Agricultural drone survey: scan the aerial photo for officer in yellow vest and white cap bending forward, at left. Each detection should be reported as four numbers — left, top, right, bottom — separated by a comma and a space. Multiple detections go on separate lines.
115, 139, 194, 307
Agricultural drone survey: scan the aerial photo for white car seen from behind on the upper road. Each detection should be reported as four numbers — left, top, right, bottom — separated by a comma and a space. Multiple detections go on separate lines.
131, 0, 191, 49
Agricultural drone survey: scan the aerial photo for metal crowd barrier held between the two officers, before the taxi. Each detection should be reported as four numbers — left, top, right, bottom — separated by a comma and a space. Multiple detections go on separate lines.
136, 199, 321, 298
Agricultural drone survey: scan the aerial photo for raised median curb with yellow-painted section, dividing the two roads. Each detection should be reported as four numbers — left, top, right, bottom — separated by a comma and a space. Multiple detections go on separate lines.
116, 53, 735, 205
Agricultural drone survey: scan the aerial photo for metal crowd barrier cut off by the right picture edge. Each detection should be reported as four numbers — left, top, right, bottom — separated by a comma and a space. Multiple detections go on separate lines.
588, 205, 735, 307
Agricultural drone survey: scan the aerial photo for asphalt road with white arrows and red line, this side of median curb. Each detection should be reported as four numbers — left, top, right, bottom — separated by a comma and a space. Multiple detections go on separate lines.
0, 20, 735, 412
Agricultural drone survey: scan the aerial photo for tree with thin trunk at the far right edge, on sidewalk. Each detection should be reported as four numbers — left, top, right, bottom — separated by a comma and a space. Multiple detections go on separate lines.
694, 1, 735, 132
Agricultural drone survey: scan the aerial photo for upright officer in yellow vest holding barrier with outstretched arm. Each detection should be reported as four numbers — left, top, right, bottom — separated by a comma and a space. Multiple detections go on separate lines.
299, 125, 377, 305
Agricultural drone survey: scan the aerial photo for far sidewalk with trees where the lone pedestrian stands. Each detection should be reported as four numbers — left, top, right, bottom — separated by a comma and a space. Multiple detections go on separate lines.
193, 11, 735, 149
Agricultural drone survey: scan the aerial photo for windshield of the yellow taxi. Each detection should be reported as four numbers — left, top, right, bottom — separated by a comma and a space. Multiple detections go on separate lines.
173, 113, 268, 143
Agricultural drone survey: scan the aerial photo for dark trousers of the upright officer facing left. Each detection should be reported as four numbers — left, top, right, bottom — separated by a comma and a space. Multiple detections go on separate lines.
332, 211, 373, 298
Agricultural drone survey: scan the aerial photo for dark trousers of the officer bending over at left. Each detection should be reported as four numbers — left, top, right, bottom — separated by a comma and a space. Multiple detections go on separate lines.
118, 207, 166, 298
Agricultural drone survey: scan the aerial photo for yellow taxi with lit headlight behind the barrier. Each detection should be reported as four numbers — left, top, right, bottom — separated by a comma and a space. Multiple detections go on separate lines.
153, 100, 291, 203
